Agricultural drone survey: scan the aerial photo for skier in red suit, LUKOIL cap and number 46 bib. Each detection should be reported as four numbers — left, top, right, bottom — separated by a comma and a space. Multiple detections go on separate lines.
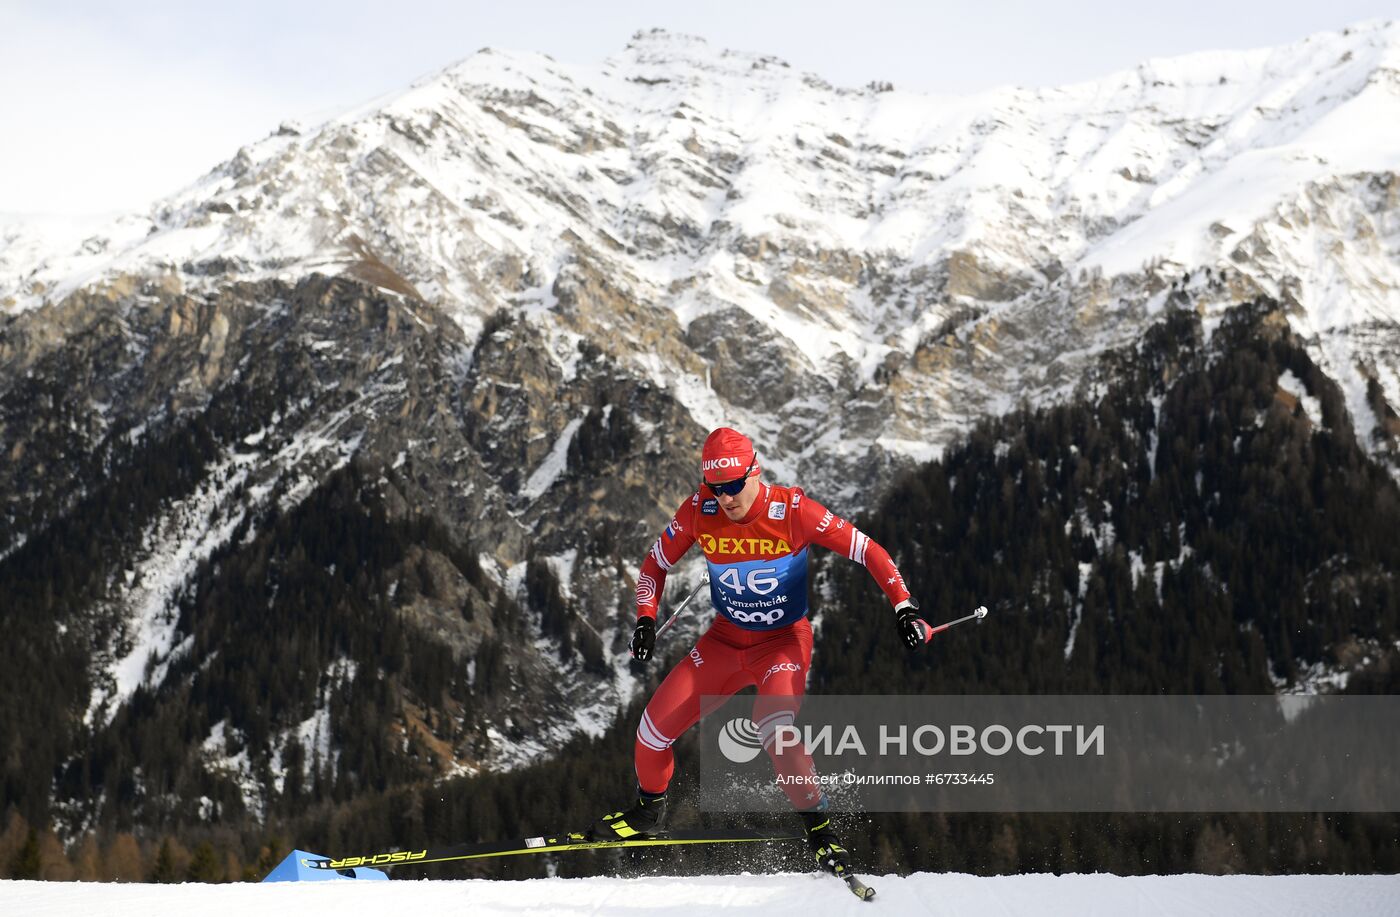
589, 427, 931, 876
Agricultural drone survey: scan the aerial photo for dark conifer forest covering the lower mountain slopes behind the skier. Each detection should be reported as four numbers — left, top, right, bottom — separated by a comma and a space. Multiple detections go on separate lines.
0, 301, 1400, 879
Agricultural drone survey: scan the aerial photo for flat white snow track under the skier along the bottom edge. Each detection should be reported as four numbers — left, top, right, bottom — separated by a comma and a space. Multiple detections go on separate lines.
0, 872, 1400, 917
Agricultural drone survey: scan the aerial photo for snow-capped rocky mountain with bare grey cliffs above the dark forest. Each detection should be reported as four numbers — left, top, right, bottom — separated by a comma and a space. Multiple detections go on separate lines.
0, 22, 1400, 823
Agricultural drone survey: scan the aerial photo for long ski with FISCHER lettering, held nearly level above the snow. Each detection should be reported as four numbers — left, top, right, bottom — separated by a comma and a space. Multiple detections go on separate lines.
302, 829, 800, 873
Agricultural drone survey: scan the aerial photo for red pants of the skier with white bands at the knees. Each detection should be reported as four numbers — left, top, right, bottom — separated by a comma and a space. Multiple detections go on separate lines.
636, 617, 822, 809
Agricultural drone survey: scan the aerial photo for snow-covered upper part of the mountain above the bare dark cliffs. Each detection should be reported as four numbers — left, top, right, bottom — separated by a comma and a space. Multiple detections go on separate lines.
10, 24, 1400, 481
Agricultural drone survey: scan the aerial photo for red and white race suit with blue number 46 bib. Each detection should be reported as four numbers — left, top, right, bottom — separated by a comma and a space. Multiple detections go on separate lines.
636, 484, 909, 809
